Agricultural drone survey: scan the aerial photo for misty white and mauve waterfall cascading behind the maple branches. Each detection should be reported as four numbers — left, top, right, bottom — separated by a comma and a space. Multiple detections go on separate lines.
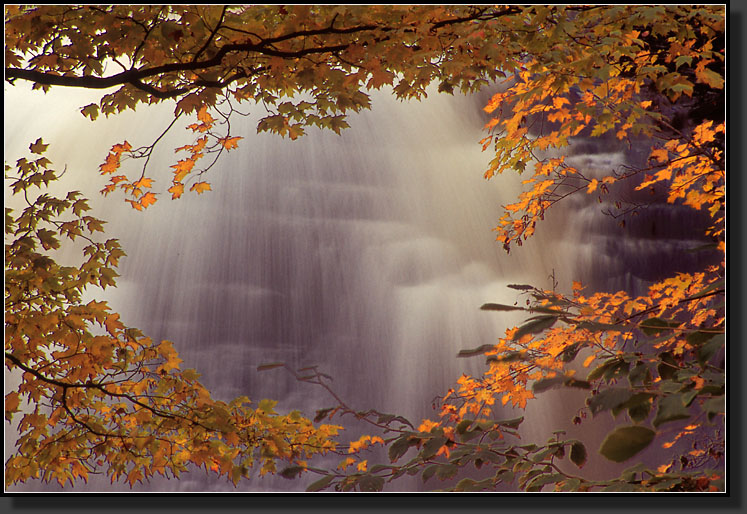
5, 82, 720, 491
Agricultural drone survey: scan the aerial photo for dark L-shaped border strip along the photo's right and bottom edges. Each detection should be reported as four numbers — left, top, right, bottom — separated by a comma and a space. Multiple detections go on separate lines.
0, 2, 747, 514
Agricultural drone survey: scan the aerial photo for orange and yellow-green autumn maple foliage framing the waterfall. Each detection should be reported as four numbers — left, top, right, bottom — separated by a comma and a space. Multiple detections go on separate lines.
5, 5, 727, 491
